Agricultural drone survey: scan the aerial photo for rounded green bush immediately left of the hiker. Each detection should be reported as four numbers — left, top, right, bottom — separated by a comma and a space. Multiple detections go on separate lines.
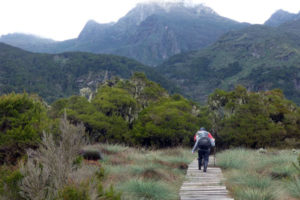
130, 99, 199, 148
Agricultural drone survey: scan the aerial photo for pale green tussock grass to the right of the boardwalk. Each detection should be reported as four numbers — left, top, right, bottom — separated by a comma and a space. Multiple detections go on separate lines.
217, 149, 300, 200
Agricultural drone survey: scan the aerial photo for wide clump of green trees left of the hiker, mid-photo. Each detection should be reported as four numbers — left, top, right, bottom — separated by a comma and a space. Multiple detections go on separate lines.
51, 73, 201, 147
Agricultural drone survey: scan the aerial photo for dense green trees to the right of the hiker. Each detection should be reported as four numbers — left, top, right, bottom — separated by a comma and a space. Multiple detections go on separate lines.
208, 86, 300, 148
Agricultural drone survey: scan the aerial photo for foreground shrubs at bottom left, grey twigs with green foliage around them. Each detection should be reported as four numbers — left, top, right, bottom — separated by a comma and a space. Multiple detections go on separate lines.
0, 115, 120, 200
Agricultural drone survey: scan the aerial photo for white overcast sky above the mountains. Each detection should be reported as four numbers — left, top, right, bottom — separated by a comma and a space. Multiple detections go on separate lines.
0, 0, 300, 40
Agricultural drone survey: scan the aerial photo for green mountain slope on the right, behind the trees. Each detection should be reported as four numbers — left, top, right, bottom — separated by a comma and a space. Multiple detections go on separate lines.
158, 23, 300, 104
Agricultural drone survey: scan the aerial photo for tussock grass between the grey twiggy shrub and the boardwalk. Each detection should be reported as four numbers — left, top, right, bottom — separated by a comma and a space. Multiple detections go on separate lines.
97, 144, 194, 200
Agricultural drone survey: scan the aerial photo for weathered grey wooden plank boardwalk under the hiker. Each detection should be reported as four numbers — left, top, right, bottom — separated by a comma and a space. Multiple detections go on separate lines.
179, 157, 233, 200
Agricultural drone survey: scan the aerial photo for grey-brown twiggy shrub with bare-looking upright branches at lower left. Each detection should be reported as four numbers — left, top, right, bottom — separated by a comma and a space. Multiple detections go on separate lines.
20, 114, 85, 199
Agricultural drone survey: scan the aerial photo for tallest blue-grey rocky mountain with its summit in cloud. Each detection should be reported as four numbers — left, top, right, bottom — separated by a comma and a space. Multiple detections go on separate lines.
0, 3, 248, 66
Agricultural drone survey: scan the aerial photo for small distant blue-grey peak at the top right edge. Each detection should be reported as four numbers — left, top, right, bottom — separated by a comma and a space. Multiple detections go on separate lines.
265, 10, 300, 27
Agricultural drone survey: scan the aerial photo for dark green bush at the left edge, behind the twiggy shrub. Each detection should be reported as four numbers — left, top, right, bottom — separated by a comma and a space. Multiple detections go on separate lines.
0, 93, 48, 165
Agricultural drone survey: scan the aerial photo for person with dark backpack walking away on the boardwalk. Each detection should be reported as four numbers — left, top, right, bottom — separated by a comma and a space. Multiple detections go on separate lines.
192, 127, 215, 172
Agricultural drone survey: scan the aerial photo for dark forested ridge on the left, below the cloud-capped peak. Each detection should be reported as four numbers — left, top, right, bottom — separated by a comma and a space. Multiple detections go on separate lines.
0, 43, 173, 102
